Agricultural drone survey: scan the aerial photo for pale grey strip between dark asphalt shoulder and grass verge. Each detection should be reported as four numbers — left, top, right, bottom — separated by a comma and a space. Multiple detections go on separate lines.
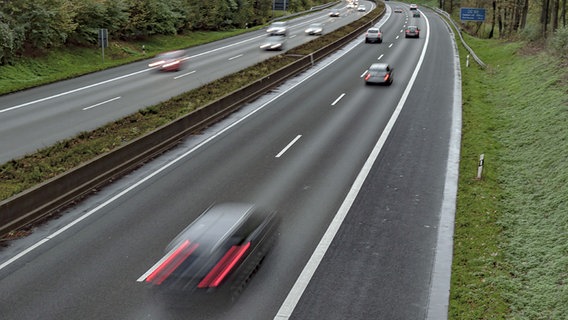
424, 12, 462, 320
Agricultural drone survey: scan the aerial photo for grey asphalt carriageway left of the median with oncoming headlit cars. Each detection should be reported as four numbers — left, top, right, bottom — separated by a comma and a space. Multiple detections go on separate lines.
0, 2, 375, 163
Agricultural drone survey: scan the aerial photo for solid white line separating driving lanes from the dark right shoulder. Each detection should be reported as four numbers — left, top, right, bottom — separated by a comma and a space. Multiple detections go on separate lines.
274, 11, 430, 320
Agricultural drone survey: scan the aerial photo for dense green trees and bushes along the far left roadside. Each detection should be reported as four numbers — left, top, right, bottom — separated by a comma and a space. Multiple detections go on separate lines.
0, 0, 332, 65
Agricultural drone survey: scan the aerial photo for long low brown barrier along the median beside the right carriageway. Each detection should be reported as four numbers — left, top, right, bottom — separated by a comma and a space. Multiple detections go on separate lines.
0, 3, 384, 235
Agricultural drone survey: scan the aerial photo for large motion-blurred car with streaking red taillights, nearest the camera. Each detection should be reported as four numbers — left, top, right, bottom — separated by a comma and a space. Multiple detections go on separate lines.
139, 203, 279, 299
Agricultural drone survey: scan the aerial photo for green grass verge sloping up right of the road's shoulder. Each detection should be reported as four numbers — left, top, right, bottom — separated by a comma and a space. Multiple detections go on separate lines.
449, 37, 568, 319
